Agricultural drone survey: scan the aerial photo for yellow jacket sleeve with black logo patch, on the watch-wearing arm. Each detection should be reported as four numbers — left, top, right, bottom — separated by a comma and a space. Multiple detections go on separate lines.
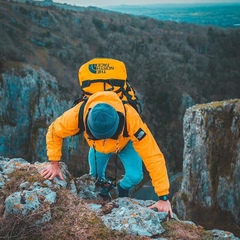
126, 106, 170, 196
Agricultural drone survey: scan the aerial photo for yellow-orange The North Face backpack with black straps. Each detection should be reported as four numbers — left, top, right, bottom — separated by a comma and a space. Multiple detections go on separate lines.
73, 58, 142, 133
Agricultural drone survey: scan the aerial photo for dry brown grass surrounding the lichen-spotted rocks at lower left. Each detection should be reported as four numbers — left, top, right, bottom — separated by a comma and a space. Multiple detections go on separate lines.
0, 167, 148, 240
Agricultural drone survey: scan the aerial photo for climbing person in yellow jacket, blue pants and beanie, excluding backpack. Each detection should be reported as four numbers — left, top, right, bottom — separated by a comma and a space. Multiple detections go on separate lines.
41, 58, 173, 217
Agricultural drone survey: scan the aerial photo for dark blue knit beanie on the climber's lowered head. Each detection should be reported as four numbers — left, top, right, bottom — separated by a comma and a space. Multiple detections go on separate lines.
87, 103, 119, 139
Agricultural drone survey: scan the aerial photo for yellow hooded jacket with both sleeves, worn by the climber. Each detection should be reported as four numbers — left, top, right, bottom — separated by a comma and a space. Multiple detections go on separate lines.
46, 92, 169, 196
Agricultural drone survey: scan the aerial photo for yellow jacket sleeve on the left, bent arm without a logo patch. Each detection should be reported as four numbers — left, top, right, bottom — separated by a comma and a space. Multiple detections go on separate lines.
46, 103, 82, 161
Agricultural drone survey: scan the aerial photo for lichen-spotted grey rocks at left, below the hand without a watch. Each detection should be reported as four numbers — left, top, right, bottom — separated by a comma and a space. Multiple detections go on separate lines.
0, 157, 76, 224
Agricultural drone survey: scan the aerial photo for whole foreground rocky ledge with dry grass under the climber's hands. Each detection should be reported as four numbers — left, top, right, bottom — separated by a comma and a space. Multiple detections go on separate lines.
0, 157, 239, 239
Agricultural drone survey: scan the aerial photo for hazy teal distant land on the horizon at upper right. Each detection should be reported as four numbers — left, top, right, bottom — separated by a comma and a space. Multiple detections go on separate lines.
107, 3, 240, 27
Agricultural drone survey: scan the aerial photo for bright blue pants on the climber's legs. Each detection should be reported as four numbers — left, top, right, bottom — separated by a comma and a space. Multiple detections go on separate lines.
88, 141, 143, 190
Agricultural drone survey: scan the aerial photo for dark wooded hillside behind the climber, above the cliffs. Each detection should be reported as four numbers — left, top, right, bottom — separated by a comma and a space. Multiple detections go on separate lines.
0, 0, 240, 172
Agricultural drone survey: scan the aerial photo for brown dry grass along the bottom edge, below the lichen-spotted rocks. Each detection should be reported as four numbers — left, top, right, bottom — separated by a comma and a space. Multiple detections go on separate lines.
0, 190, 148, 240
